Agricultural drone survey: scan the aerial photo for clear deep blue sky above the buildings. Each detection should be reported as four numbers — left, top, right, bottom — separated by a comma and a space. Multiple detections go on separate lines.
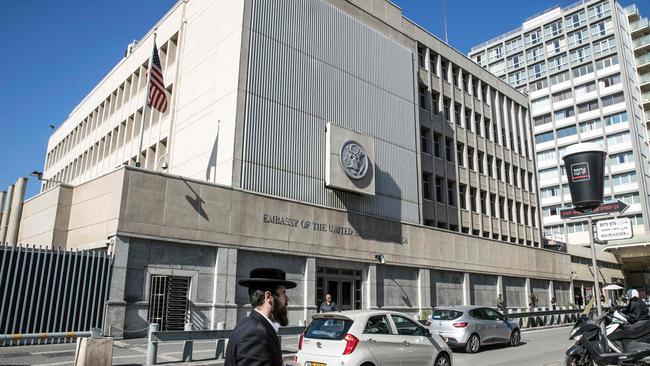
0, 0, 650, 198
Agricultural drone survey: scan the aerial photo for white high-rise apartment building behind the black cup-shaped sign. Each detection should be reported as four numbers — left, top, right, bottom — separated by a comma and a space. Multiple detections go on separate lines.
470, 0, 650, 244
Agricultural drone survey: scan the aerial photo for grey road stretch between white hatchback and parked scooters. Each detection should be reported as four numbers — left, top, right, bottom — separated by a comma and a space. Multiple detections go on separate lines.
454, 327, 571, 366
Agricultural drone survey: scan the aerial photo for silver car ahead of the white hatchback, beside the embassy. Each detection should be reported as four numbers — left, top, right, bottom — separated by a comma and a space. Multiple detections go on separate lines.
426, 306, 521, 353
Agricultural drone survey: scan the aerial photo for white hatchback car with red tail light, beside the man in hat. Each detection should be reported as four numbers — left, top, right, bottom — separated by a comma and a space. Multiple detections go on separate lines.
295, 310, 452, 366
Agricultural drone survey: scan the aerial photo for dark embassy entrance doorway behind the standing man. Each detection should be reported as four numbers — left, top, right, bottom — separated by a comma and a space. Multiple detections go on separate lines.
315, 267, 362, 311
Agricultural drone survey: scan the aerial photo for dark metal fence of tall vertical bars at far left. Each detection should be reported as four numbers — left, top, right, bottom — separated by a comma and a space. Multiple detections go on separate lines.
0, 246, 113, 346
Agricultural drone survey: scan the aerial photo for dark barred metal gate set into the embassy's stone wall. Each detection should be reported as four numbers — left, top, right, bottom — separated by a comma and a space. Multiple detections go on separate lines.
147, 275, 190, 331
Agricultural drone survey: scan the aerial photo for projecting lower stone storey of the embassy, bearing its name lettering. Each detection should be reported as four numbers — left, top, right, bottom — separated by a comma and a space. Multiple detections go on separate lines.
21, 167, 571, 336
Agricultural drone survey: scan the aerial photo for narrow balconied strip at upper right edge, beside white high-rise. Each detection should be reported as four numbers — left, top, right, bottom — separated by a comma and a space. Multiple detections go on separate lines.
625, 4, 650, 141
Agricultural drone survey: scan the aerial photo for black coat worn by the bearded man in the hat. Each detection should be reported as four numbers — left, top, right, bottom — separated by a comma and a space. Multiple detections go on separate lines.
224, 310, 282, 366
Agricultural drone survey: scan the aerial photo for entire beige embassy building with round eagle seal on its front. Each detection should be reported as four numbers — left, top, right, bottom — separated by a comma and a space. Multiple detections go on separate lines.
19, 0, 622, 336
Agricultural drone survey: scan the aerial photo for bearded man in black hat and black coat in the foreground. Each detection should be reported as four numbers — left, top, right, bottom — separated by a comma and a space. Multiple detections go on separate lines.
224, 268, 296, 366
